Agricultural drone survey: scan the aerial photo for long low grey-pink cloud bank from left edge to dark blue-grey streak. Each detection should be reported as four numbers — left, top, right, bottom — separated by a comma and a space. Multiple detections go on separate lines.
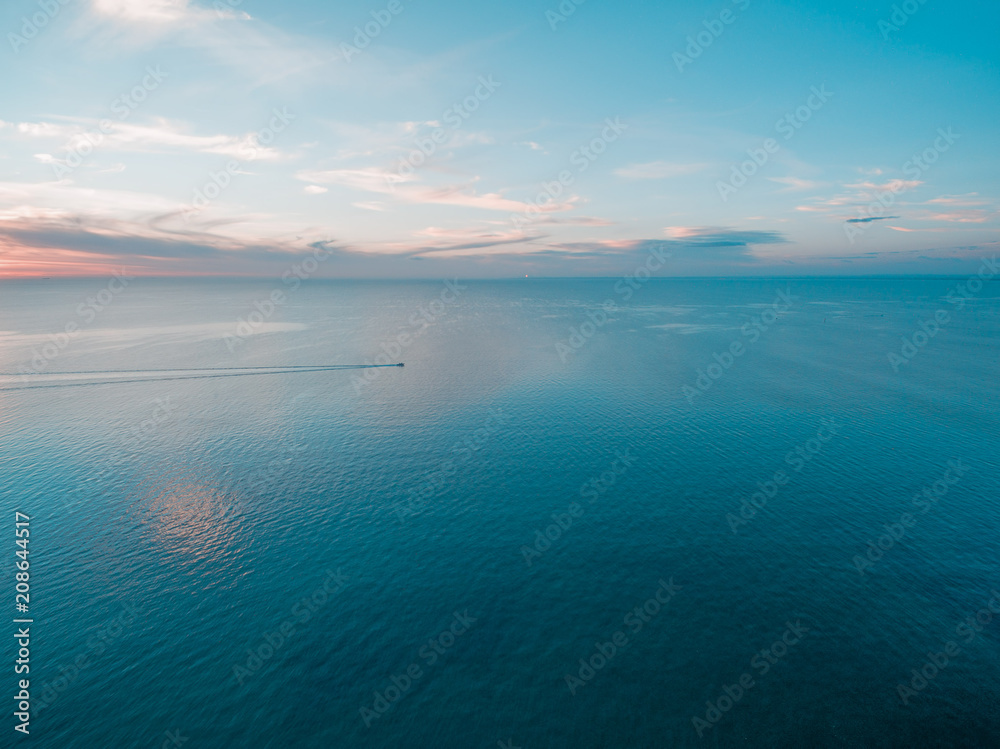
0, 218, 785, 275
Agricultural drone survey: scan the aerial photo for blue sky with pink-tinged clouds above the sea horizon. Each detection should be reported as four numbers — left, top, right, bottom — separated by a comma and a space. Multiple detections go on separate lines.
0, 0, 1000, 278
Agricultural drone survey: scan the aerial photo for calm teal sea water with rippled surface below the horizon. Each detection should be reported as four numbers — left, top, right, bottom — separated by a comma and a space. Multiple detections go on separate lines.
0, 278, 1000, 748
